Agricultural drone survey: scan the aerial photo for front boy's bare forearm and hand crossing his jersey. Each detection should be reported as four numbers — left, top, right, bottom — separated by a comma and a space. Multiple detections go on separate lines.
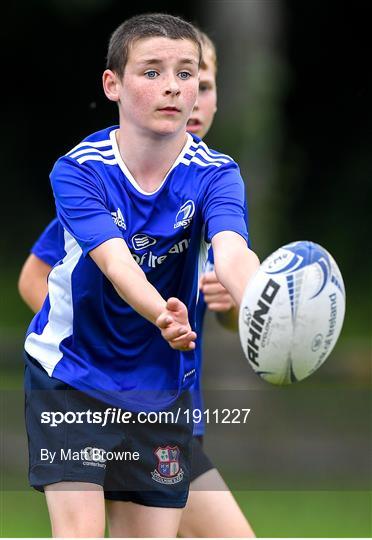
89, 238, 196, 350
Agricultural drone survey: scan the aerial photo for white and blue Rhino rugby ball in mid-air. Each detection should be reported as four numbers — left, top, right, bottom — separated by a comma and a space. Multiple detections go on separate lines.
239, 241, 345, 385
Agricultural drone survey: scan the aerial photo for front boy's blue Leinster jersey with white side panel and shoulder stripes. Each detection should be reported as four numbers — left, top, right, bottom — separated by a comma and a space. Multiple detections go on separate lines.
25, 127, 247, 411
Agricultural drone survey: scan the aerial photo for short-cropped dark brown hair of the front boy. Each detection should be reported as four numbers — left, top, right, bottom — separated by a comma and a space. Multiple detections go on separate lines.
106, 13, 202, 78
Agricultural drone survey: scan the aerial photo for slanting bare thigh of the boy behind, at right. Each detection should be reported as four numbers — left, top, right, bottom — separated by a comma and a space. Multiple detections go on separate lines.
179, 469, 254, 538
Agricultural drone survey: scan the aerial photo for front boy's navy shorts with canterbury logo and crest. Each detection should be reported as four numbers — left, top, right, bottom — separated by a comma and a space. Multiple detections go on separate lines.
25, 355, 192, 508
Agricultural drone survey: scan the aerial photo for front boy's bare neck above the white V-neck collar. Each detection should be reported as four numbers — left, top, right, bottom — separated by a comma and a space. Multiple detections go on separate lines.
116, 122, 187, 193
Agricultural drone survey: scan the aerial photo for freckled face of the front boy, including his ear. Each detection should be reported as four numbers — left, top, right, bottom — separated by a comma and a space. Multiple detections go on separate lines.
104, 37, 199, 135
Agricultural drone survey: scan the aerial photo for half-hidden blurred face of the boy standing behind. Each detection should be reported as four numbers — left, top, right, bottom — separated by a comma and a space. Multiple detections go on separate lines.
186, 47, 217, 138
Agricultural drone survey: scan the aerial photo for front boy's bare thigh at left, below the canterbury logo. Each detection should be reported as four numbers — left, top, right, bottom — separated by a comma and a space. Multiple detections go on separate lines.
44, 482, 105, 538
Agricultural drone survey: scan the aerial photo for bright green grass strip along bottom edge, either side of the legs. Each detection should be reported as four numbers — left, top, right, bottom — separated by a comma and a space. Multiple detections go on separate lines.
0, 490, 372, 538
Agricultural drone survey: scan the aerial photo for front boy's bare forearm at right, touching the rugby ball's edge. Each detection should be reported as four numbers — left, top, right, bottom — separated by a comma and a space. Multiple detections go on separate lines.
212, 231, 260, 306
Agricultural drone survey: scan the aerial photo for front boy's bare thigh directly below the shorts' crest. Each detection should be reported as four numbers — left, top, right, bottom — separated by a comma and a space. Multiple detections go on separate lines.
106, 501, 182, 538
